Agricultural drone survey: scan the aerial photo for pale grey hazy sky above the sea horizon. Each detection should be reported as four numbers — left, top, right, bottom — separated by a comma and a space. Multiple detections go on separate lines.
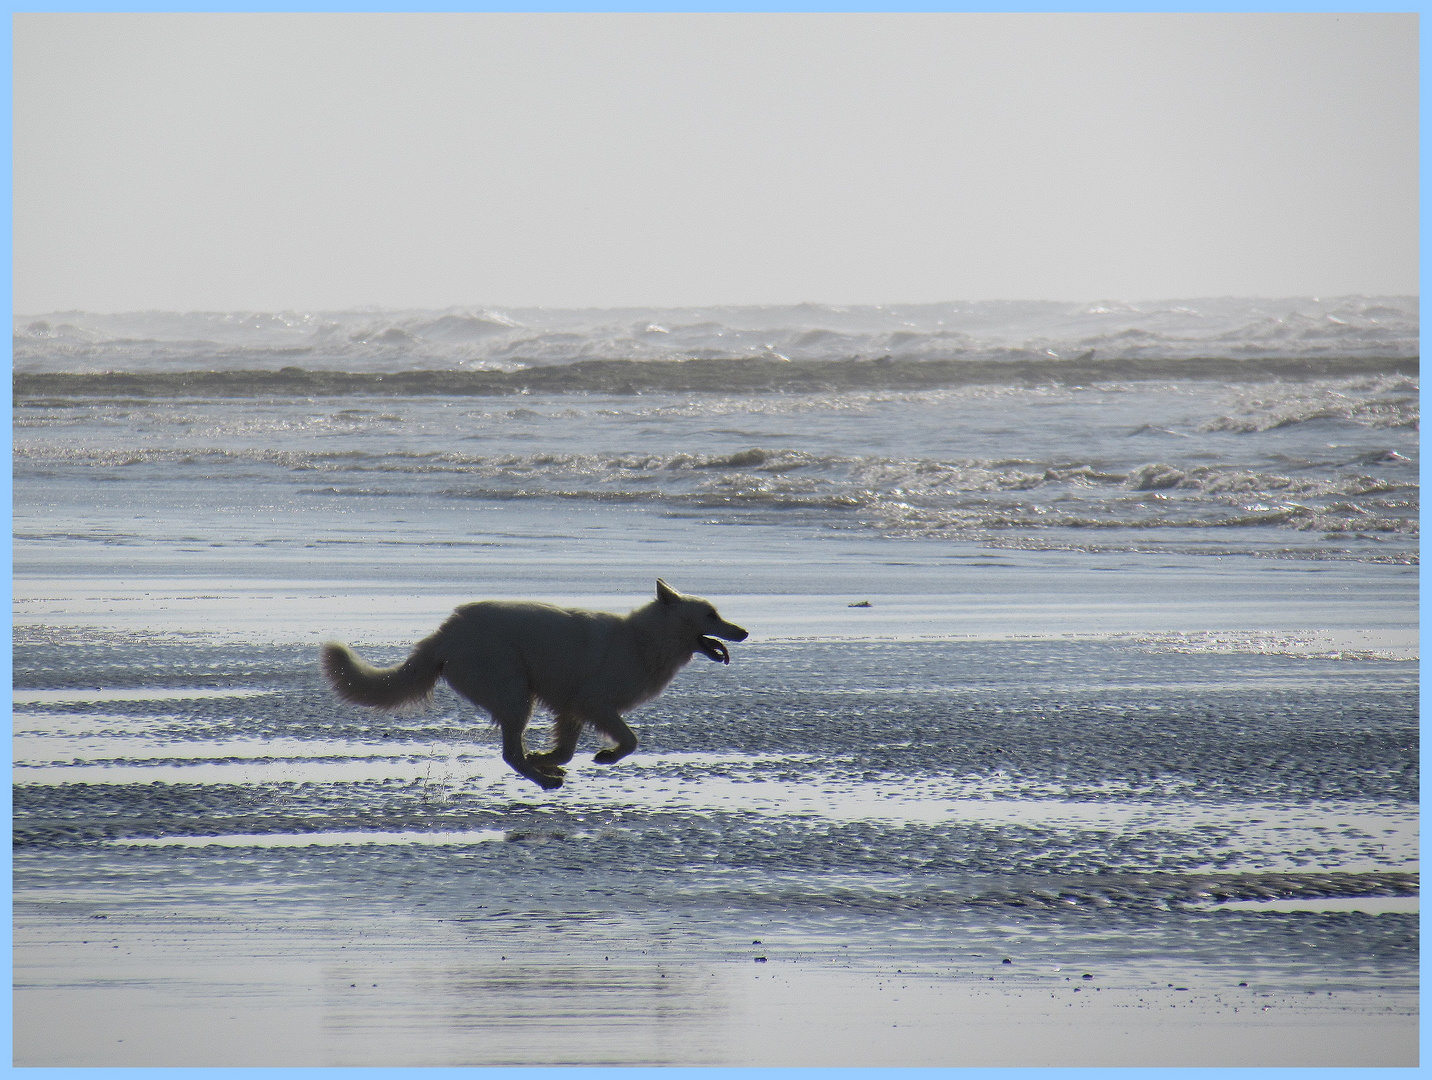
14, 14, 1418, 314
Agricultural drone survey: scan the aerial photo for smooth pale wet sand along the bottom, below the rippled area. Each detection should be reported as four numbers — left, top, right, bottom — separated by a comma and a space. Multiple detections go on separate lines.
16, 912, 1418, 1067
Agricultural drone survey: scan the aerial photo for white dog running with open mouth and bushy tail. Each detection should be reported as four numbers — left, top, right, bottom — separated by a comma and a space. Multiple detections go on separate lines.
322, 579, 748, 789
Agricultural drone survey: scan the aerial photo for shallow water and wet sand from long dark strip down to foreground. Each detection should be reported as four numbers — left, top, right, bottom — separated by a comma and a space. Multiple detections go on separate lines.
13, 375, 1419, 1066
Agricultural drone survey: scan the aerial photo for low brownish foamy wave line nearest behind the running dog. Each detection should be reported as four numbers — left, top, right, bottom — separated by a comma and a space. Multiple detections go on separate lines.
14, 443, 1419, 539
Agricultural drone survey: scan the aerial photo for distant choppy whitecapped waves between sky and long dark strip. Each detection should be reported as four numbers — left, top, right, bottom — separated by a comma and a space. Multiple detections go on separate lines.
13, 296, 1419, 372
